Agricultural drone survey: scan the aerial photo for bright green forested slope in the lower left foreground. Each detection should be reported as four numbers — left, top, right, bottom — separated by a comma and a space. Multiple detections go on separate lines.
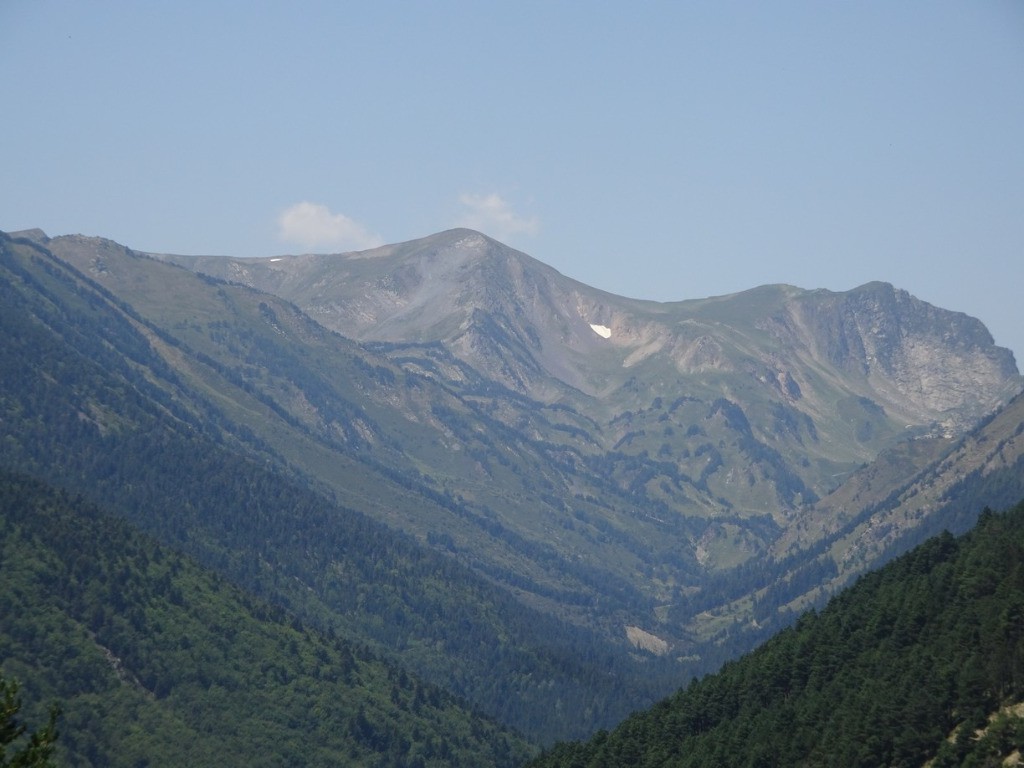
0, 473, 528, 766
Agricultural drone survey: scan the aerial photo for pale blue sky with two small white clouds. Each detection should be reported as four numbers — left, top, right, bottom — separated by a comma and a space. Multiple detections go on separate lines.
6, 0, 1024, 367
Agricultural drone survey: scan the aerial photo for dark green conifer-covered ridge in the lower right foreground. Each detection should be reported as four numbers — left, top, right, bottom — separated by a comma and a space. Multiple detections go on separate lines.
531, 503, 1024, 768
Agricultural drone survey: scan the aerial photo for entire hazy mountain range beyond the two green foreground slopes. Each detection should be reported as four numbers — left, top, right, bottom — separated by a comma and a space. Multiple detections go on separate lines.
0, 229, 1024, 742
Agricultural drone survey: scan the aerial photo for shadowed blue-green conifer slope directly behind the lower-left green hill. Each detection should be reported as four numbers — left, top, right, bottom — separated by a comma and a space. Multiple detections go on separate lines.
0, 230, 670, 743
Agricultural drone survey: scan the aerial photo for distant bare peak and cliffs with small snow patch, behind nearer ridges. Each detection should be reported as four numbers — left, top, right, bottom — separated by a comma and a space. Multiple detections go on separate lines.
155, 229, 1021, 513
